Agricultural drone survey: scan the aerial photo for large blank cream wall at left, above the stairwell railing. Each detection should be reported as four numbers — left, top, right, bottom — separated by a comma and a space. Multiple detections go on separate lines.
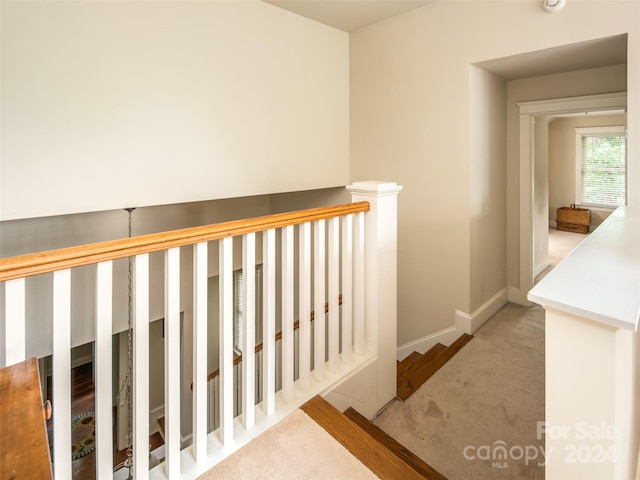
0, 0, 349, 220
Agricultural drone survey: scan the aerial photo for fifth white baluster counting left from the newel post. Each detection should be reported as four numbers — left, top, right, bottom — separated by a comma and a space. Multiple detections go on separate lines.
298, 222, 311, 391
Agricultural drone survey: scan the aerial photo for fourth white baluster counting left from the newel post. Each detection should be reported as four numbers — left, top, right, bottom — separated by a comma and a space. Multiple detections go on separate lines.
313, 220, 326, 382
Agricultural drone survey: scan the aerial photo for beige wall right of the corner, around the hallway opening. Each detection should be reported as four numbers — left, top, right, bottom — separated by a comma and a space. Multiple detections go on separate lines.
350, 0, 640, 344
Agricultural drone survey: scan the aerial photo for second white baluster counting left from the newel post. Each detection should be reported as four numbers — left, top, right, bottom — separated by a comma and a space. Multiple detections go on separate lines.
342, 215, 353, 363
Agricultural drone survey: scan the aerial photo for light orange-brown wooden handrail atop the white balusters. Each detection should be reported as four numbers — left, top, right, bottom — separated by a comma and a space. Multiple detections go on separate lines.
0, 202, 369, 282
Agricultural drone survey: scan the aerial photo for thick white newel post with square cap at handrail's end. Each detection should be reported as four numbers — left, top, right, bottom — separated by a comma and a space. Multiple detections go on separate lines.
347, 182, 402, 409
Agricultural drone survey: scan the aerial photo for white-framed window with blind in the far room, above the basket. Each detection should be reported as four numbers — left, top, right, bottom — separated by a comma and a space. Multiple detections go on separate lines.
576, 126, 627, 207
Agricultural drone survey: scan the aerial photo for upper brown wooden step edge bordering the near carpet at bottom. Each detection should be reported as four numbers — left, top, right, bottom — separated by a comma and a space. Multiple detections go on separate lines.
300, 396, 424, 480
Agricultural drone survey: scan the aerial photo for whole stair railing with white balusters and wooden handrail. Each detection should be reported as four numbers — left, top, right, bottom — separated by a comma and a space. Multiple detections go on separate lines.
0, 184, 399, 480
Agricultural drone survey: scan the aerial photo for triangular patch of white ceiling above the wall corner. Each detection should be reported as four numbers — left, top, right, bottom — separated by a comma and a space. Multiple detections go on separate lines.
262, 0, 435, 32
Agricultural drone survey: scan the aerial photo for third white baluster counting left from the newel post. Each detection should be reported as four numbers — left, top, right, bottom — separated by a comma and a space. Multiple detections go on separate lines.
328, 217, 340, 372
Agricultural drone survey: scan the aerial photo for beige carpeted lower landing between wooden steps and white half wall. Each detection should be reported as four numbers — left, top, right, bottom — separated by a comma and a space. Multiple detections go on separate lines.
375, 304, 545, 480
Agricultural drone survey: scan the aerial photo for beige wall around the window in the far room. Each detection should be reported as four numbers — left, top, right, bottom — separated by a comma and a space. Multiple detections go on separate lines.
549, 115, 627, 227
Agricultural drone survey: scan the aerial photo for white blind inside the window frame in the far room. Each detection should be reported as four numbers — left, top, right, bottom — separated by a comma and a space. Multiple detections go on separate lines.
581, 134, 627, 206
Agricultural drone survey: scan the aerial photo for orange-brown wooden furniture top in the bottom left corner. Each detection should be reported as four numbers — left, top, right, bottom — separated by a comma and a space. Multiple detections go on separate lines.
0, 358, 53, 479
